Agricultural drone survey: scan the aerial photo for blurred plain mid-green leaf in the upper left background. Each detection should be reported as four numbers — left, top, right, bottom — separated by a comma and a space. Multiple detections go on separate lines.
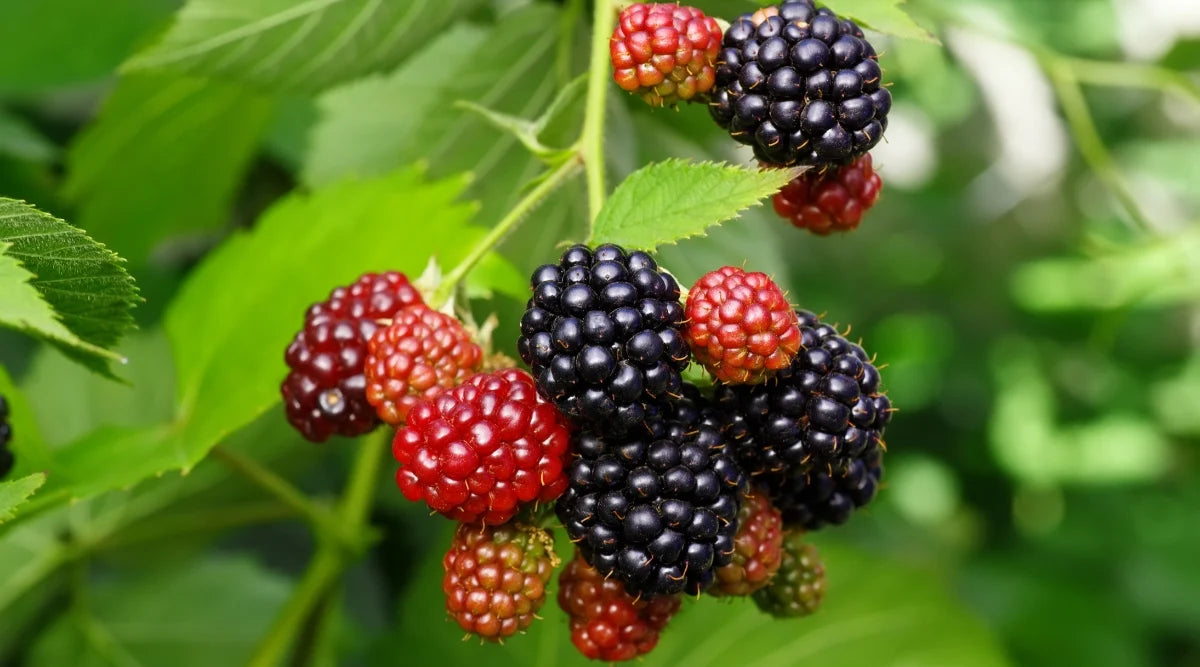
64, 74, 272, 266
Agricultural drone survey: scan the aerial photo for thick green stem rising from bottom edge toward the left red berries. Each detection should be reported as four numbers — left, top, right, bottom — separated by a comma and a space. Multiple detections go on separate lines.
248, 428, 390, 667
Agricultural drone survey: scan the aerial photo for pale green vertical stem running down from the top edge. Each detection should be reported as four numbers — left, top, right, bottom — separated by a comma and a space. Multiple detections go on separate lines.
580, 0, 617, 225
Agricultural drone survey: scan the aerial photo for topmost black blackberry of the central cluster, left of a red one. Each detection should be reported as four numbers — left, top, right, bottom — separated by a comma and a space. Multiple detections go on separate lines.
517, 245, 688, 434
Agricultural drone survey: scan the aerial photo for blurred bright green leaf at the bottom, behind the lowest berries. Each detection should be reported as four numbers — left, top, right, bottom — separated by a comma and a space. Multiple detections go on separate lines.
371, 528, 1007, 667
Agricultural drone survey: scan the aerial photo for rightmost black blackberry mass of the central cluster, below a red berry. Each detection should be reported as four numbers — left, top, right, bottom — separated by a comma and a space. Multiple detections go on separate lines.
714, 311, 892, 529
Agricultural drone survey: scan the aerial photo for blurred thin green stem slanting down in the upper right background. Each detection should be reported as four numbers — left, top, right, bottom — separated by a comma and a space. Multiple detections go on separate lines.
1043, 58, 1153, 232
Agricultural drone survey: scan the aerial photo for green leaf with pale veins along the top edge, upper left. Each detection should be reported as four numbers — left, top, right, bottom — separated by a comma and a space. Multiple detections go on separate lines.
124, 0, 481, 91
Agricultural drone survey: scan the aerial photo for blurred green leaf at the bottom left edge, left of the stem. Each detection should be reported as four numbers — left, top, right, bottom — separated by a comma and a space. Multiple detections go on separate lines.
29, 557, 290, 667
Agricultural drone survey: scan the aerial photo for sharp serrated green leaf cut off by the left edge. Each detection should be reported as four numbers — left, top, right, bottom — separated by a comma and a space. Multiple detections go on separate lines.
0, 198, 138, 373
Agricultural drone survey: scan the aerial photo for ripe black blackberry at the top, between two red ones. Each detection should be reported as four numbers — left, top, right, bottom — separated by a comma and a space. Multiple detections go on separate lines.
709, 0, 892, 167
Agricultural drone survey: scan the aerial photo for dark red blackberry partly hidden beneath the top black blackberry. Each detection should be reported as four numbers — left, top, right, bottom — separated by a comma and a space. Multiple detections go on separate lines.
774, 154, 883, 236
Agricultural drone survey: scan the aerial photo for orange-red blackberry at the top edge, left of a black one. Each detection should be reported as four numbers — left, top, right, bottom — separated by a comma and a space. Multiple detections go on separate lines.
608, 2, 721, 107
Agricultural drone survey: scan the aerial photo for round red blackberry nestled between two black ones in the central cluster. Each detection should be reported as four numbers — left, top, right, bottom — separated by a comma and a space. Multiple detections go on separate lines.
683, 266, 800, 384
